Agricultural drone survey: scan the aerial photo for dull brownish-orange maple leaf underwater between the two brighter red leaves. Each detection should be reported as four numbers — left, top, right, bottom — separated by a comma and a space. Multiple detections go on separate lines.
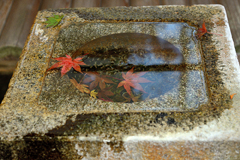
83, 72, 114, 90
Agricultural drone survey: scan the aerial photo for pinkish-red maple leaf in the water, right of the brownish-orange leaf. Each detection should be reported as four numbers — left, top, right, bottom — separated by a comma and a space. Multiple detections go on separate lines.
118, 67, 152, 96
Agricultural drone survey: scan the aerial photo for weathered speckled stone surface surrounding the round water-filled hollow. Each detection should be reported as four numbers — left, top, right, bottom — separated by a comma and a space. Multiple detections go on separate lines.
0, 5, 240, 159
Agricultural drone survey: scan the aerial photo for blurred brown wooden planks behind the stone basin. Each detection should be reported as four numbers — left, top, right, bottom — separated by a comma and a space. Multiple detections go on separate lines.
0, 0, 240, 102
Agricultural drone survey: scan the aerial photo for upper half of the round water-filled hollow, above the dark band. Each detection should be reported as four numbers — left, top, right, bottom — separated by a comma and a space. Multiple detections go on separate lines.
73, 33, 183, 66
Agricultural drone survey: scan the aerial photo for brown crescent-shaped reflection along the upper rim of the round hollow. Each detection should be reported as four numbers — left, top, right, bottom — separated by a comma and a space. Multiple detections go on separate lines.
73, 33, 181, 61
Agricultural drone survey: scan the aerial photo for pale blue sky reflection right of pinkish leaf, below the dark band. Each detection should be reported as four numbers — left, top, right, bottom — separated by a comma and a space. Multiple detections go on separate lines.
132, 71, 208, 109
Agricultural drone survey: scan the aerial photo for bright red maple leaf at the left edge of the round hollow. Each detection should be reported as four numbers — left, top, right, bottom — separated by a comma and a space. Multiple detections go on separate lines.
47, 55, 86, 77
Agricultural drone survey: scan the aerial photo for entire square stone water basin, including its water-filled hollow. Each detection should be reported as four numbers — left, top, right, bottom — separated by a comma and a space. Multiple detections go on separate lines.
0, 5, 240, 159
